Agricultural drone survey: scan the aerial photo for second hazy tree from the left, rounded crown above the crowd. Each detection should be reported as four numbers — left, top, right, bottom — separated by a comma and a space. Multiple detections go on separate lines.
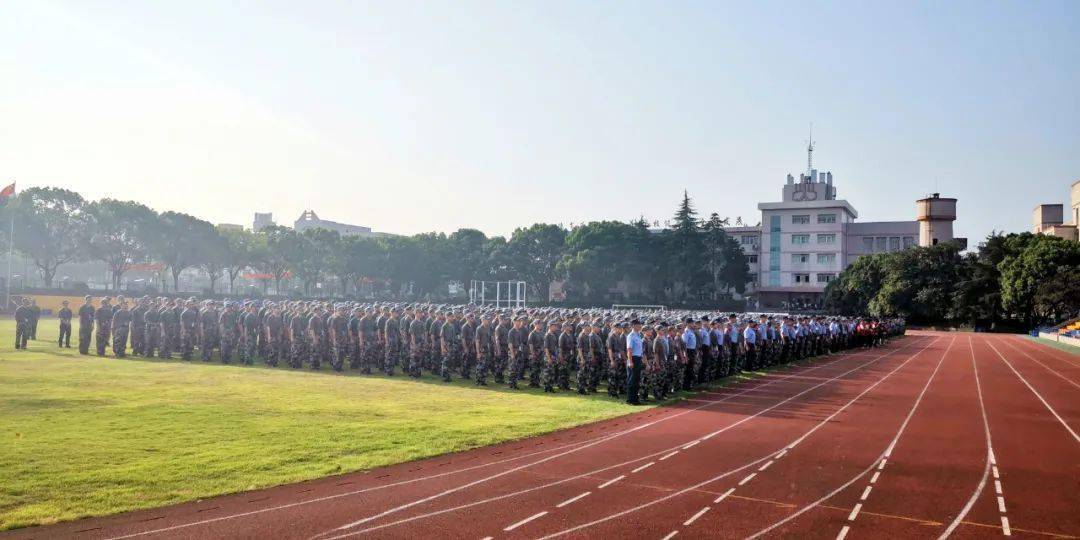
85, 199, 158, 291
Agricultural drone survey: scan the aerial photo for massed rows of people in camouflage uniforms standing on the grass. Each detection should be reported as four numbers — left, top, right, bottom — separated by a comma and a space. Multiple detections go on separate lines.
16, 296, 904, 403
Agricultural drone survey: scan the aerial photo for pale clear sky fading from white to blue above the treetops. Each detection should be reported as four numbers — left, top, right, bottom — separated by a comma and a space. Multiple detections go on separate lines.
0, 0, 1080, 240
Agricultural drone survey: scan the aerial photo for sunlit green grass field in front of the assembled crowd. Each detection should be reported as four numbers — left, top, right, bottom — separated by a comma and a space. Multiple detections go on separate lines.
0, 319, 640, 530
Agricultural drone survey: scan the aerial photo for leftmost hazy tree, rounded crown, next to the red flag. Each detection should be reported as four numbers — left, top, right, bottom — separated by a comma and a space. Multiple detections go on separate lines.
11, 188, 93, 287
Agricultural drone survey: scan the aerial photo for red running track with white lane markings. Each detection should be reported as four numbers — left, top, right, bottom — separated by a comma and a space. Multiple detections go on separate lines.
2, 332, 1080, 540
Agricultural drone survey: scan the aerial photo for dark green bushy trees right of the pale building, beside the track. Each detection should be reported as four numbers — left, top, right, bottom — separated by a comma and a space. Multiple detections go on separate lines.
825, 232, 1080, 328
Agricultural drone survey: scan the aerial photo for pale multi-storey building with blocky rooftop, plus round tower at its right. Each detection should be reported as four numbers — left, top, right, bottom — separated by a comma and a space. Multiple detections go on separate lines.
726, 164, 956, 309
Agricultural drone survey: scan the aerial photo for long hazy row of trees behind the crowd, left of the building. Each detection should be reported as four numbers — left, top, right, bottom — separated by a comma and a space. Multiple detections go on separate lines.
0, 188, 750, 303
